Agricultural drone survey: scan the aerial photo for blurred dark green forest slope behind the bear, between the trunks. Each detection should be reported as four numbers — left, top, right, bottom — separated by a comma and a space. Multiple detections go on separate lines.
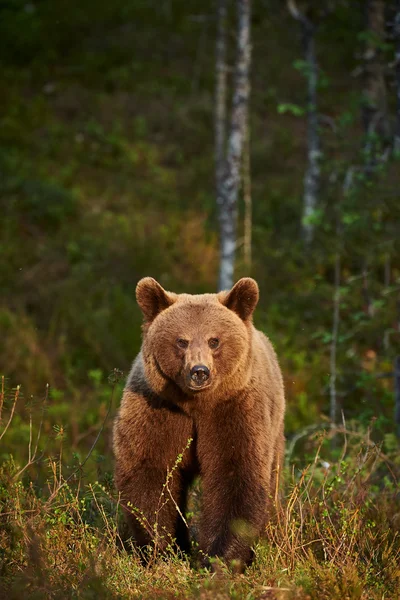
0, 0, 400, 434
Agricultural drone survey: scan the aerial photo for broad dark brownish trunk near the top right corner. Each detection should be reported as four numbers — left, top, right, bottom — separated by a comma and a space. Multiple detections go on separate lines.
362, 0, 390, 165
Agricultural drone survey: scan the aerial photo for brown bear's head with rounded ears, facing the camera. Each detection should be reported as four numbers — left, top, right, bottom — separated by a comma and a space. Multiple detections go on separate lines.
136, 277, 258, 396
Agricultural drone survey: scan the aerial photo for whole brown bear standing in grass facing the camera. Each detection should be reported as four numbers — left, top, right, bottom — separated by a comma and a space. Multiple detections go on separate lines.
114, 277, 285, 565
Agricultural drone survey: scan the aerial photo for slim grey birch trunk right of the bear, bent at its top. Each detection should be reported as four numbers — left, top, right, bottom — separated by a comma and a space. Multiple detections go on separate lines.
288, 0, 321, 244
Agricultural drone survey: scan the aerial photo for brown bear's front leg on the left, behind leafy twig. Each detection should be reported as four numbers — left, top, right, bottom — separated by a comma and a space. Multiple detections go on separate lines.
114, 389, 192, 550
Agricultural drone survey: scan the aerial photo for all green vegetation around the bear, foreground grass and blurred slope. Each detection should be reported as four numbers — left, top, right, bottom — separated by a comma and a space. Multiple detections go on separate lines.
0, 0, 400, 600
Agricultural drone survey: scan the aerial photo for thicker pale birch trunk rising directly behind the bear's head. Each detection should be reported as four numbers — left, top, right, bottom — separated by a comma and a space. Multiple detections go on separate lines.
217, 0, 251, 290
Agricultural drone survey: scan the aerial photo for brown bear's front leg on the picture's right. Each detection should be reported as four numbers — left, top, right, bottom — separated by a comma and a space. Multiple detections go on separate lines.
197, 401, 273, 568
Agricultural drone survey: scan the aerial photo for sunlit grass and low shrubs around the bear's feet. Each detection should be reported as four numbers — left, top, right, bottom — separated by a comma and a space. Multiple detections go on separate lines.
0, 388, 400, 600
